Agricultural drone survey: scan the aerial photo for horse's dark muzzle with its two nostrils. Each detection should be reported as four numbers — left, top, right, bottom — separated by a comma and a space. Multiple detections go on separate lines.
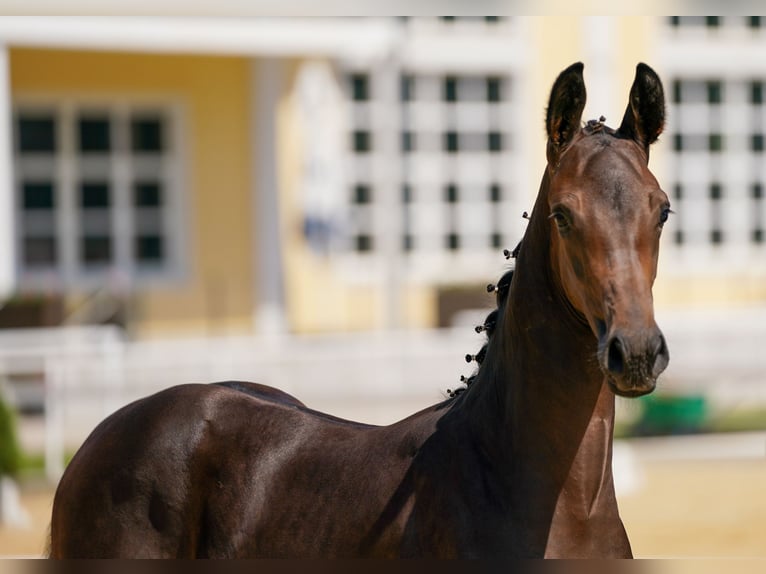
598, 326, 670, 397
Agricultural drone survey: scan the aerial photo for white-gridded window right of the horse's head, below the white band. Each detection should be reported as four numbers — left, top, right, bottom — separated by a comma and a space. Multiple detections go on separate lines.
668, 74, 766, 250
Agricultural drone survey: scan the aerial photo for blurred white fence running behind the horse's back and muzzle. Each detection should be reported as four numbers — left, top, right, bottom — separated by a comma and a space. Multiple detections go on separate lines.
0, 308, 766, 480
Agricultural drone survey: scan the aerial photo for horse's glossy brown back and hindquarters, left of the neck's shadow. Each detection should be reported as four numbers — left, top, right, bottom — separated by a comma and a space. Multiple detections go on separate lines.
51, 381, 440, 558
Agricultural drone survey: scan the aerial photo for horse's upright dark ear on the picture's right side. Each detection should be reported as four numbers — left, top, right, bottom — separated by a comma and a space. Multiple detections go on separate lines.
617, 63, 665, 151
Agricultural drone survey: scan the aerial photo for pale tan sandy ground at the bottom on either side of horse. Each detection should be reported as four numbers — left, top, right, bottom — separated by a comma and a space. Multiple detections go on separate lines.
0, 433, 766, 560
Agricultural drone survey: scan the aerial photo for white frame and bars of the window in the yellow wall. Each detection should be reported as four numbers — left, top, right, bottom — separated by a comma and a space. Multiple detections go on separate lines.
12, 92, 190, 293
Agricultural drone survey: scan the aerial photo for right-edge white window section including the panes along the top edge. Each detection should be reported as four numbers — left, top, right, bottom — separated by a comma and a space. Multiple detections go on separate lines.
661, 15, 766, 264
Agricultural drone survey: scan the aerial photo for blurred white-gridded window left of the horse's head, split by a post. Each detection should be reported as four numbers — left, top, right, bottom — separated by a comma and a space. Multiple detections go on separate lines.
345, 68, 523, 260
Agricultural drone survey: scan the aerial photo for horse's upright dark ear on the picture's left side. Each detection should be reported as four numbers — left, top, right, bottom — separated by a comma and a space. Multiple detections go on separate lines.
545, 62, 585, 162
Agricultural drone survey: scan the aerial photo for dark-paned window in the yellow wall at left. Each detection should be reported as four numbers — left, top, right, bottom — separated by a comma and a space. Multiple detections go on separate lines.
13, 101, 181, 285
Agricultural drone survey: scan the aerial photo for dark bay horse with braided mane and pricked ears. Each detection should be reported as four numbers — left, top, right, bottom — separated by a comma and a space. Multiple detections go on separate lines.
50, 63, 670, 558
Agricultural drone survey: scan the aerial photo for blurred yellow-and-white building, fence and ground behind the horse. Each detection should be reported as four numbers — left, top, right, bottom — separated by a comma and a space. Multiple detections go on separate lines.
0, 16, 766, 556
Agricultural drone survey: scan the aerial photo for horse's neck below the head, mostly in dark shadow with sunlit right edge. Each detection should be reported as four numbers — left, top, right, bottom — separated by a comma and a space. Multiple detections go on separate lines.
465, 169, 614, 547
